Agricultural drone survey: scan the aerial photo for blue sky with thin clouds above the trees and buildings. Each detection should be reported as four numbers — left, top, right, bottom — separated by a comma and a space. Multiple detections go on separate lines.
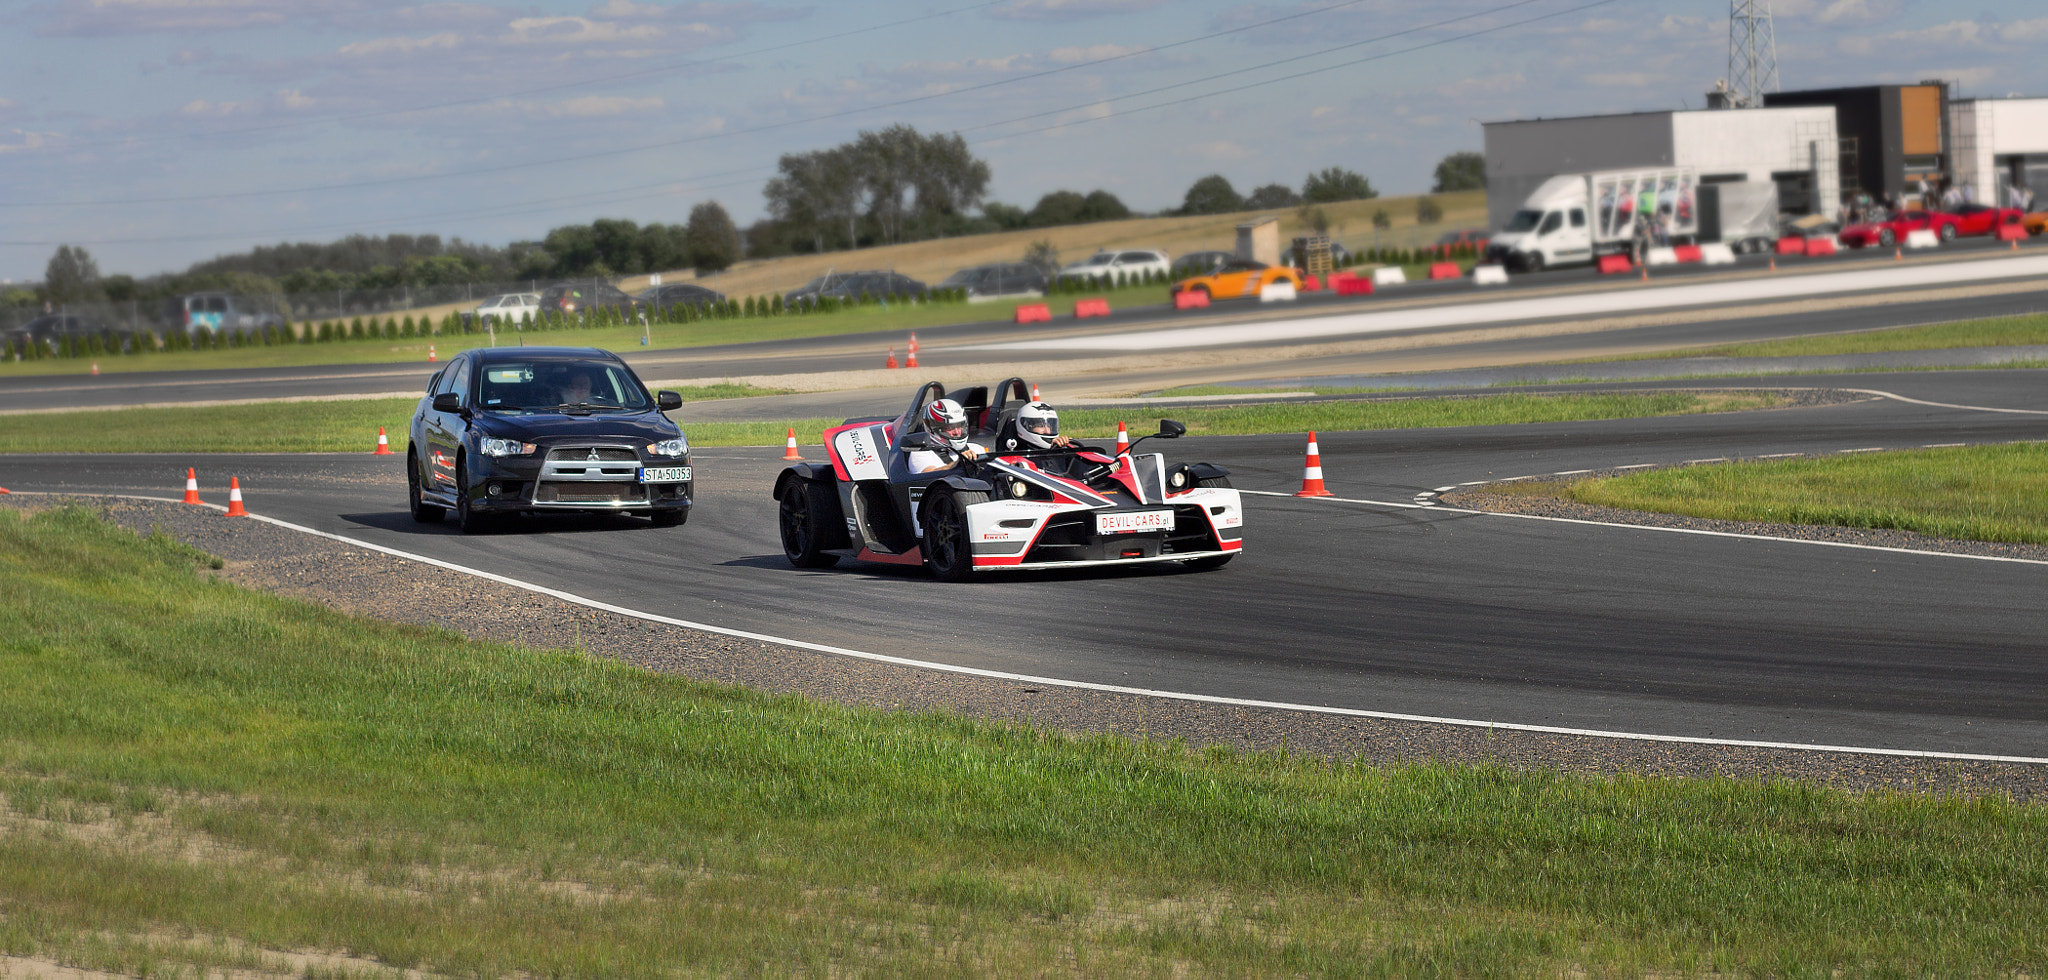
0, 0, 2048, 282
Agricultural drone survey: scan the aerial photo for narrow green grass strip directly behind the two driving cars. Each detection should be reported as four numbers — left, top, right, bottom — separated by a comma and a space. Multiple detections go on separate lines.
0, 385, 1782, 452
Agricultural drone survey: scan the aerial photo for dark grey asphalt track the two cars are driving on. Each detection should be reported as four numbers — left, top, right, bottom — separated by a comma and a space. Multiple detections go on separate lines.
0, 370, 2048, 759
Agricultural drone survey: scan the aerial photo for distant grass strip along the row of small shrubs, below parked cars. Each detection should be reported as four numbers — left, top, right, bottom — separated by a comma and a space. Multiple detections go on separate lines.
0, 286, 1167, 378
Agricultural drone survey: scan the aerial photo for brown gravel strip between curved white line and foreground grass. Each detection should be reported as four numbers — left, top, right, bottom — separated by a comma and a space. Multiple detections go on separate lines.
0, 493, 2048, 802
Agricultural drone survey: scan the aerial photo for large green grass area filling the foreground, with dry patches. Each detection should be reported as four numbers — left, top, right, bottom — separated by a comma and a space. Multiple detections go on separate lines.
0, 509, 2048, 976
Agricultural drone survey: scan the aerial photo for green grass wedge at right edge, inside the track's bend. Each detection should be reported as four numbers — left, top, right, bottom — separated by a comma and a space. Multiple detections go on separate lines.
1530, 442, 2048, 544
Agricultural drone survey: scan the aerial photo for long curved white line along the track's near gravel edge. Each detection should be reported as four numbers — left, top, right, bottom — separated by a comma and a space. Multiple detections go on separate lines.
14, 491, 2048, 765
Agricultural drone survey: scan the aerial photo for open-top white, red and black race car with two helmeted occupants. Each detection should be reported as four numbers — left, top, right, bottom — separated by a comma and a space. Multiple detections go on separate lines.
774, 378, 1245, 581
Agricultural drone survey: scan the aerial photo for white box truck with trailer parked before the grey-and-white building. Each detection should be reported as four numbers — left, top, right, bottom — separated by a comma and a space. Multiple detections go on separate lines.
1487, 168, 1778, 272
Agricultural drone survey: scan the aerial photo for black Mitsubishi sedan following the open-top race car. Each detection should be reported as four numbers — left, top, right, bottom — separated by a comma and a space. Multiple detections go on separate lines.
406, 348, 690, 532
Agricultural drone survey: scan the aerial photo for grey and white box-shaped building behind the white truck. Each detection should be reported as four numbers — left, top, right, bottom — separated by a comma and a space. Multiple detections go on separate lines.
1485, 106, 1851, 227
